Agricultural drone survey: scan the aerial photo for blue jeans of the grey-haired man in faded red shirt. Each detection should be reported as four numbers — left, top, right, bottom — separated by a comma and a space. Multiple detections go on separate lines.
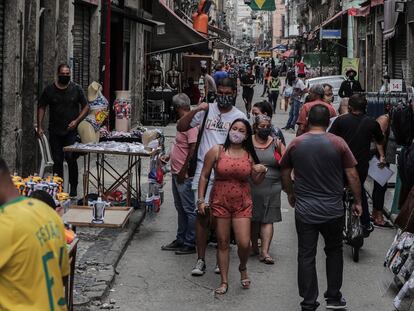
172, 174, 196, 247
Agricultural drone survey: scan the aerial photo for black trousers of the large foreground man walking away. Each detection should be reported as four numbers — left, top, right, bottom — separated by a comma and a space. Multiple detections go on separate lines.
296, 217, 344, 311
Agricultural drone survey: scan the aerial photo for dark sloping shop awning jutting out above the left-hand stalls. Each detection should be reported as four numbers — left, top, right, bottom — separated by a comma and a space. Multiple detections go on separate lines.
148, 0, 211, 54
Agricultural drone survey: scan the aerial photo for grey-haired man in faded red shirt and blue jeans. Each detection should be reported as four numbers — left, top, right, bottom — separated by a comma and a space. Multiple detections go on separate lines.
161, 93, 198, 255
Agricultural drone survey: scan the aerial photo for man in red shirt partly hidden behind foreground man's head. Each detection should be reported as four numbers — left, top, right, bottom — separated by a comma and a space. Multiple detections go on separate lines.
296, 84, 336, 136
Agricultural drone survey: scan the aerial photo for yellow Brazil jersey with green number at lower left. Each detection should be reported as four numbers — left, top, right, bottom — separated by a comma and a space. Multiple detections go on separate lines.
0, 197, 69, 311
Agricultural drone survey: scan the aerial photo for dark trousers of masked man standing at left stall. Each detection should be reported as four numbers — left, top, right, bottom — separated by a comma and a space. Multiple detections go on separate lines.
49, 131, 78, 191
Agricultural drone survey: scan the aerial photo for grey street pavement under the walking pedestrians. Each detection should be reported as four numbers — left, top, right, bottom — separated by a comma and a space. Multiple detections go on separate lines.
100, 86, 395, 311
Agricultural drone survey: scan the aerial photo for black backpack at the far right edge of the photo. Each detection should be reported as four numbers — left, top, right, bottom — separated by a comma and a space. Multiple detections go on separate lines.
391, 105, 414, 147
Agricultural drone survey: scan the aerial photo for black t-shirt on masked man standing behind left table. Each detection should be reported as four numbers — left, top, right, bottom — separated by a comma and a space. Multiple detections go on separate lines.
39, 82, 88, 135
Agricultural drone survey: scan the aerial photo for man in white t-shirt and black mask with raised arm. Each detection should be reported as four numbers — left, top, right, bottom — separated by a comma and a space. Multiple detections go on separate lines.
177, 78, 246, 276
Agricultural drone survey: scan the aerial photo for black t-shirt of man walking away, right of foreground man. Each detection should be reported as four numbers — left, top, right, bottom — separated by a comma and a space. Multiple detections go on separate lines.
329, 113, 384, 177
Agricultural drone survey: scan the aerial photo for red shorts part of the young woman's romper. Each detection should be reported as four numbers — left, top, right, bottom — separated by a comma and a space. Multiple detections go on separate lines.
210, 181, 253, 218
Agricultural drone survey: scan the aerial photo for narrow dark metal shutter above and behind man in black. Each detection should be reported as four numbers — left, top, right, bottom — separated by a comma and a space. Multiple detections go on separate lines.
73, 4, 91, 91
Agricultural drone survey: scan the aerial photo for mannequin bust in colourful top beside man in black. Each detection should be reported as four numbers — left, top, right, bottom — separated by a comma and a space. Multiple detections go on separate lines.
78, 81, 108, 144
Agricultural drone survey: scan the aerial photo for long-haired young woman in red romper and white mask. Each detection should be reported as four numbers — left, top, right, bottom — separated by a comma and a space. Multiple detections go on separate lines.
197, 119, 267, 294
